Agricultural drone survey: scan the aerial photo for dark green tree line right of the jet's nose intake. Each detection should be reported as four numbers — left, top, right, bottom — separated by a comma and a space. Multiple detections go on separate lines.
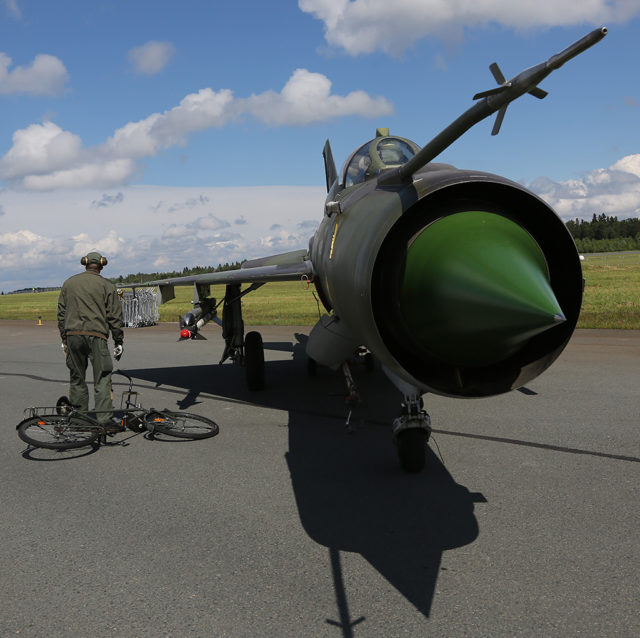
566, 213, 640, 253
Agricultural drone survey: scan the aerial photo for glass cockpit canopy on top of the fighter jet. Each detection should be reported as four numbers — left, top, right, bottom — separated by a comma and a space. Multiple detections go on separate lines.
342, 129, 420, 187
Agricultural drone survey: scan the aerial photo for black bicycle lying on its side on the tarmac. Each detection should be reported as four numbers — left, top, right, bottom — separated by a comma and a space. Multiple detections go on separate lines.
16, 370, 219, 450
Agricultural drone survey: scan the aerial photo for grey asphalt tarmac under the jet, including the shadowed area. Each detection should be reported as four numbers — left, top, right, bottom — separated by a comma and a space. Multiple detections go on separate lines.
0, 321, 640, 638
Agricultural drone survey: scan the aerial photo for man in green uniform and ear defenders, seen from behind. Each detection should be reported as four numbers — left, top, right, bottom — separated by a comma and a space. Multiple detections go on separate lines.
58, 252, 124, 426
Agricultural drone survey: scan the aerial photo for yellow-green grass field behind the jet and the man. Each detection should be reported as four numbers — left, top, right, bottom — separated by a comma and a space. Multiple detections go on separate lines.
0, 253, 640, 330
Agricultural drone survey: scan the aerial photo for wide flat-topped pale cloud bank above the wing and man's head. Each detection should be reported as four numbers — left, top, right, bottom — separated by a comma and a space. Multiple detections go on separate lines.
0, 186, 326, 292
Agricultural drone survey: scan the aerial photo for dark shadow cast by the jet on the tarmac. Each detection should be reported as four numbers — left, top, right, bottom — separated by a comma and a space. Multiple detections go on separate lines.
127, 335, 485, 636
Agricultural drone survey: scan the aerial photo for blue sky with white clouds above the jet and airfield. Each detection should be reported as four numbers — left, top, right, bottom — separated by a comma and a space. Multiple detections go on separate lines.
0, 0, 640, 291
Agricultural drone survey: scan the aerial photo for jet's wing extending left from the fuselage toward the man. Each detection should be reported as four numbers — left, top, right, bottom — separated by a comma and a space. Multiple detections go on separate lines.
127, 250, 313, 303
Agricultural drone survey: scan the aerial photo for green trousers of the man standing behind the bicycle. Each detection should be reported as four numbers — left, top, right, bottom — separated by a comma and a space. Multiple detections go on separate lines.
67, 335, 113, 423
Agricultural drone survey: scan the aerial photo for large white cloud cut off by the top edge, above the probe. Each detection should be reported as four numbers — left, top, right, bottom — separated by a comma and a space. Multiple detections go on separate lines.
298, 0, 640, 55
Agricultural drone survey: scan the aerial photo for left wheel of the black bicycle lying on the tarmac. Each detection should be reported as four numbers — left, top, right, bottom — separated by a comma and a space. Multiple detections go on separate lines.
17, 414, 100, 450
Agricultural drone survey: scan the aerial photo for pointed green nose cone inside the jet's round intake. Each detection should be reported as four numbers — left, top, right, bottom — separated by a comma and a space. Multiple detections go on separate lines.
400, 211, 565, 366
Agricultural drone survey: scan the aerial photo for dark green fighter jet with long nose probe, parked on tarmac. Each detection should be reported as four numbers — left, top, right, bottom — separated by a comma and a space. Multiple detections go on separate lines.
130, 27, 607, 472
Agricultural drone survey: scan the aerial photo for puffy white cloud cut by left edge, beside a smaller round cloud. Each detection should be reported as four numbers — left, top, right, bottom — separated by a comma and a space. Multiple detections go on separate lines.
0, 53, 69, 95
